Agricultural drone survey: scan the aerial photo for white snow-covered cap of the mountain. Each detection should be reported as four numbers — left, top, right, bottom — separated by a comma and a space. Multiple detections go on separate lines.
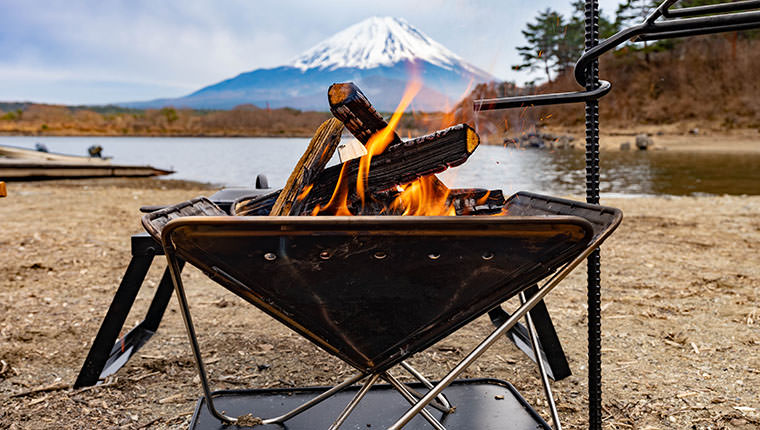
290, 17, 484, 75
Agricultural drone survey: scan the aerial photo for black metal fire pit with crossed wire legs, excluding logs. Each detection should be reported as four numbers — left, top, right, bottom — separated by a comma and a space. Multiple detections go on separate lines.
143, 193, 622, 428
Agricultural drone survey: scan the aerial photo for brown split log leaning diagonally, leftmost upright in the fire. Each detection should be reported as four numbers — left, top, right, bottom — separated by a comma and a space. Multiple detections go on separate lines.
269, 118, 343, 216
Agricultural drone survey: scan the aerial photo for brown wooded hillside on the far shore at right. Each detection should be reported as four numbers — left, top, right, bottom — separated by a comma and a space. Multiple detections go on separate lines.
454, 34, 760, 141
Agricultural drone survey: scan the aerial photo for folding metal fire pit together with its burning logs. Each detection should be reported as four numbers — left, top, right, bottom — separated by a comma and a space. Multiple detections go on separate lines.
137, 84, 622, 429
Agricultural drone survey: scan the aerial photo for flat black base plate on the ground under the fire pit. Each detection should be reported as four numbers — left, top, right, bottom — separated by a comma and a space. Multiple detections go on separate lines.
190, 379, 550, 430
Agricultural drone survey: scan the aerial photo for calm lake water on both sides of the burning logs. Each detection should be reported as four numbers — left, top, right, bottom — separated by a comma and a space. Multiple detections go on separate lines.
0, 136, 760, 196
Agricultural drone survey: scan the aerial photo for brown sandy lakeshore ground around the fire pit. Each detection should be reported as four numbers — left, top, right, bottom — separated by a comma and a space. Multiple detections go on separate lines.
0, 176, 760, 429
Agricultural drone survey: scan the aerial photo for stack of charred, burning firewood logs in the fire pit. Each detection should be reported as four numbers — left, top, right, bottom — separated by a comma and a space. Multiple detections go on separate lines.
233, 83, 504, 216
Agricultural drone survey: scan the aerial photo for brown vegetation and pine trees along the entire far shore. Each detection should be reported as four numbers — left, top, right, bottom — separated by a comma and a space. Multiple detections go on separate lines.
0, 0, 760, 137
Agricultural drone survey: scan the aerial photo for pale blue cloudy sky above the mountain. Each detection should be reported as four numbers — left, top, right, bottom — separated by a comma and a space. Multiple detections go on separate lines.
0, 0, 619, 105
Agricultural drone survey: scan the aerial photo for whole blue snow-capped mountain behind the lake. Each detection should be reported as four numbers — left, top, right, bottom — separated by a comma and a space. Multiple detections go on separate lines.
120, 17, 495, 111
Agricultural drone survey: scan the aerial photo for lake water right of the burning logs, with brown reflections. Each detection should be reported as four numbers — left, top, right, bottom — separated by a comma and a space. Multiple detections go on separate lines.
442, 146, 760, 195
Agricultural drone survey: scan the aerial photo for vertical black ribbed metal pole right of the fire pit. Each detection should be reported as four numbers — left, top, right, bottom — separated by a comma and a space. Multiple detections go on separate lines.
585, 0, 602, 430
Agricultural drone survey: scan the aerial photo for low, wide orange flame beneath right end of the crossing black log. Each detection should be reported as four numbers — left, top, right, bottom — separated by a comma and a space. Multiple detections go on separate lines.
389, 175, 456, 216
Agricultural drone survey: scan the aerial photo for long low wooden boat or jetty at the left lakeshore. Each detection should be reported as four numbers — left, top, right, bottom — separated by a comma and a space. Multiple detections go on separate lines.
0, 145, 174, 181
